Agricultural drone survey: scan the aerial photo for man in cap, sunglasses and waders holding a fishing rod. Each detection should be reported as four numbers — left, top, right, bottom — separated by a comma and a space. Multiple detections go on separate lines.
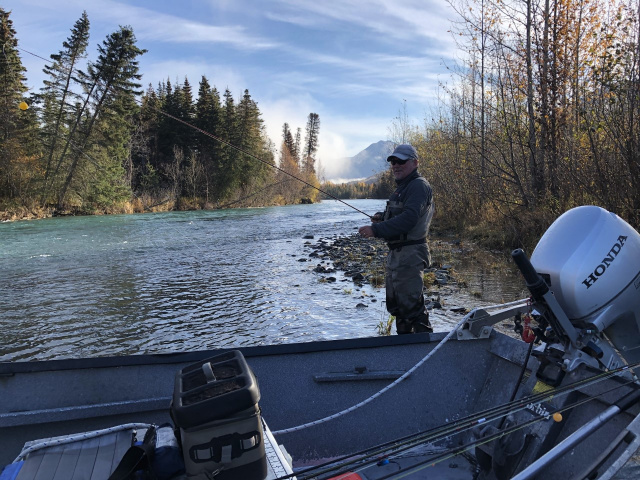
358, 144, 434, 334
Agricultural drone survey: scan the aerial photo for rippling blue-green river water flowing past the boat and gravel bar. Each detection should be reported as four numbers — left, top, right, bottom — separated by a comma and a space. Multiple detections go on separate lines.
0, 200, 526, 361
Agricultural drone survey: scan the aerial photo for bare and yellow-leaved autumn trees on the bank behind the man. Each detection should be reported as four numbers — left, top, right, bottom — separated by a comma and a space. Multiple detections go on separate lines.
404, 0, 640, 247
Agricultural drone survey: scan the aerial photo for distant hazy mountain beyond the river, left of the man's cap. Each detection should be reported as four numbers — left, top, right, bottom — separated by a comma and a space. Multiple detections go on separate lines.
327, 140, 394, 183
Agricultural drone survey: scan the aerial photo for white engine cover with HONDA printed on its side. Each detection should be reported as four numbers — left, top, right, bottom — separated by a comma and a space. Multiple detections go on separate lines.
531, 206, 640, 363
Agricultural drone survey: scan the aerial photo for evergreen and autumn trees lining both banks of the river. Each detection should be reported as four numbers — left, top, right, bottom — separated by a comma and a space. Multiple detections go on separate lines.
0, 0, 640, 251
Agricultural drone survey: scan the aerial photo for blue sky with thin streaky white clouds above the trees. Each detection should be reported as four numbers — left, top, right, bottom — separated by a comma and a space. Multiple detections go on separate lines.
1, 0, 457, 179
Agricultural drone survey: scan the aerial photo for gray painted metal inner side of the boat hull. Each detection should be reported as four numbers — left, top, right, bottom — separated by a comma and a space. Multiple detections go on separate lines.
0, 332, 637, 478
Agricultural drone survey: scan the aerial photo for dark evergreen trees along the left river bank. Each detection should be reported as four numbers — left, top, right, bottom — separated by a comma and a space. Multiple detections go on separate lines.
0, 9, 320, 218
